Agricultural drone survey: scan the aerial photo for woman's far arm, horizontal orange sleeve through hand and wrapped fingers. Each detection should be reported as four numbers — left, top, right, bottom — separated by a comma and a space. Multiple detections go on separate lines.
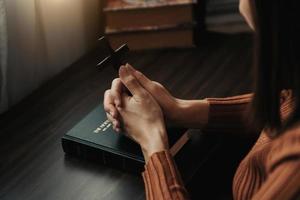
104, 65, 252, 135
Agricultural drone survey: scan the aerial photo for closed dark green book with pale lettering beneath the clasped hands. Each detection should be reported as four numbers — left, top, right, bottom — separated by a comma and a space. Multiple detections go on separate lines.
62, 105, 189, 173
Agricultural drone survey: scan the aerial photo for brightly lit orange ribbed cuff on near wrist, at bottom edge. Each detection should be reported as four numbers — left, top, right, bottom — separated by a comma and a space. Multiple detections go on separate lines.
142, 151, 188, 200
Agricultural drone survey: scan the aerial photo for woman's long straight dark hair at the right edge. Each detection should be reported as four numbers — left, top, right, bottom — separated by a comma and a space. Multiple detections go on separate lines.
252, 0, 300, 133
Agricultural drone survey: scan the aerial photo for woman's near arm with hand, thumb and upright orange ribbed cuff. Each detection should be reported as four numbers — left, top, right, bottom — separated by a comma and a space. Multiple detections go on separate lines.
107, 66, 187, 200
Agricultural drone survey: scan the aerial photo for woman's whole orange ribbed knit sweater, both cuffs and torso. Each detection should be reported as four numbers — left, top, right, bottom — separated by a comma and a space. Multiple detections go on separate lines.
142, 95, 300, 200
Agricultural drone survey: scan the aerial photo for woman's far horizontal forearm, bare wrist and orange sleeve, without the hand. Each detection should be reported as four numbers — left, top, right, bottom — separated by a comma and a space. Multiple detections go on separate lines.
172, 94, 252, 132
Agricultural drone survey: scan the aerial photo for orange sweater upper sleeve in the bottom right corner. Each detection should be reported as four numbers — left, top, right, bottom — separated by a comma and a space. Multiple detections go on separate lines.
253, 130, 300, 200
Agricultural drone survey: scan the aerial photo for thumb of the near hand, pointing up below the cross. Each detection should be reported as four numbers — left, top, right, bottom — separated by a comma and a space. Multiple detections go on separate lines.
119, 65, 145, 97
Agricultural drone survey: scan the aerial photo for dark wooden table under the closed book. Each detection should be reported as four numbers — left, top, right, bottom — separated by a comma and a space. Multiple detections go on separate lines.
0, 34, 252, 200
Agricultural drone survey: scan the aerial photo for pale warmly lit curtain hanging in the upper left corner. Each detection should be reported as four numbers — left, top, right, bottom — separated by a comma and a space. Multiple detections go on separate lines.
0, 0, 103, 110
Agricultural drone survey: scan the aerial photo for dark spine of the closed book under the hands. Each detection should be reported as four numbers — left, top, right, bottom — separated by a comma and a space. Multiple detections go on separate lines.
61, 138, 144, 174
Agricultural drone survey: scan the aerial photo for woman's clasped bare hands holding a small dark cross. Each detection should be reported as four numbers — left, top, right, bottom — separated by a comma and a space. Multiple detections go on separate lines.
104, 64, 176, 161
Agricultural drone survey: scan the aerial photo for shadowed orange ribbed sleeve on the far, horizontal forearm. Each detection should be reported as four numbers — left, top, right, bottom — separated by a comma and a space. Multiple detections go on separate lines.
203, 94, 254, 133
